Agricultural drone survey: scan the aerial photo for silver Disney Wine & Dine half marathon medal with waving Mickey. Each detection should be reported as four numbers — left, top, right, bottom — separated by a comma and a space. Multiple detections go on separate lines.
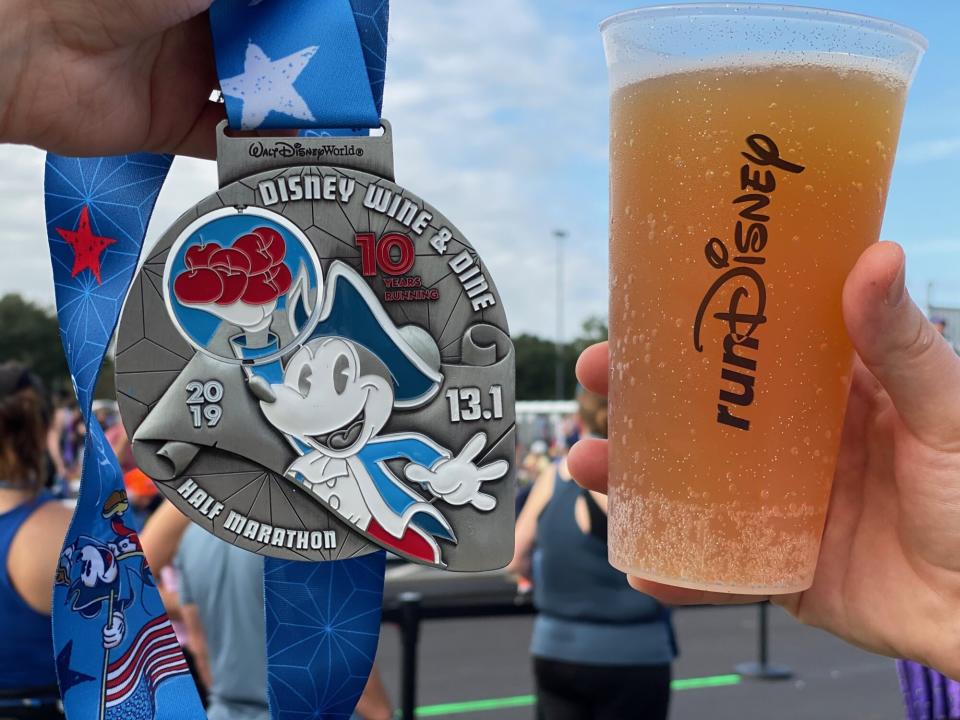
116, 122, 514, 570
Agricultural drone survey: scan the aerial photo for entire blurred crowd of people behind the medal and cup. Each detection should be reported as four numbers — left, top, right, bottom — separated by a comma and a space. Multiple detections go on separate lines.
0, 363, 676, 720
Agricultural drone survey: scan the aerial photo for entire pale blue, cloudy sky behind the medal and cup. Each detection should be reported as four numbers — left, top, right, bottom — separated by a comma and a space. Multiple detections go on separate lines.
0, 0, 960, 338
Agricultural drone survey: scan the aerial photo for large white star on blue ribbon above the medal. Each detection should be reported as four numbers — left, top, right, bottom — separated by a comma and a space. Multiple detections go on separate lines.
220, 41, 319, 130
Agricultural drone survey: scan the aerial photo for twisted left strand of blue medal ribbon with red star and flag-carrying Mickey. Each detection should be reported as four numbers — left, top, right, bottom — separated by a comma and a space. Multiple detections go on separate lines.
44, 153, 205, 720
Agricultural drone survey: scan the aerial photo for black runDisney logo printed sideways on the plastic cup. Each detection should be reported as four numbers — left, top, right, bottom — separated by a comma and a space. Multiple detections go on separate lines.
693, 134, 805, 430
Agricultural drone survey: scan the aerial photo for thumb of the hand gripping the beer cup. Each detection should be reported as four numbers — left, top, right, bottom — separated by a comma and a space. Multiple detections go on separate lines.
843, 242, 960, 446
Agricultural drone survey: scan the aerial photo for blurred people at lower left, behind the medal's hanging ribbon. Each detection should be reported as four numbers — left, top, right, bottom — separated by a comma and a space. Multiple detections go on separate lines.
0, 362, 393, 720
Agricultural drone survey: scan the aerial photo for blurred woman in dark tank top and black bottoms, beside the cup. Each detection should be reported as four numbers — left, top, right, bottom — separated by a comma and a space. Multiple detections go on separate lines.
509, 390, 676, 720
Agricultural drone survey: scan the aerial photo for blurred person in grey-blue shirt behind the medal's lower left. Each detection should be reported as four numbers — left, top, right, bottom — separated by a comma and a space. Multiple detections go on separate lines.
140, 502, 393, 720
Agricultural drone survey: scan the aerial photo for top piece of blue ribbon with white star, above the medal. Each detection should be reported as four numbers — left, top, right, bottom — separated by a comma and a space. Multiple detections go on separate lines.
210, 0, 389, 129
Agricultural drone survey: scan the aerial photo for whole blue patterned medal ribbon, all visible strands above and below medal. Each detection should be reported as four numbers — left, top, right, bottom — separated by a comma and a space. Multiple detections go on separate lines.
44, 0, 388, 720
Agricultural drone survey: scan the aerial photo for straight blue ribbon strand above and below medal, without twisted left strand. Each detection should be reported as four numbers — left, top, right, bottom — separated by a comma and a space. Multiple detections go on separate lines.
210, 0, 388, 720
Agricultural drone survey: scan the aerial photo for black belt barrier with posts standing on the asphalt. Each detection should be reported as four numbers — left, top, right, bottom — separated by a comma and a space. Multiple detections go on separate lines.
383, 591, 793, 720
